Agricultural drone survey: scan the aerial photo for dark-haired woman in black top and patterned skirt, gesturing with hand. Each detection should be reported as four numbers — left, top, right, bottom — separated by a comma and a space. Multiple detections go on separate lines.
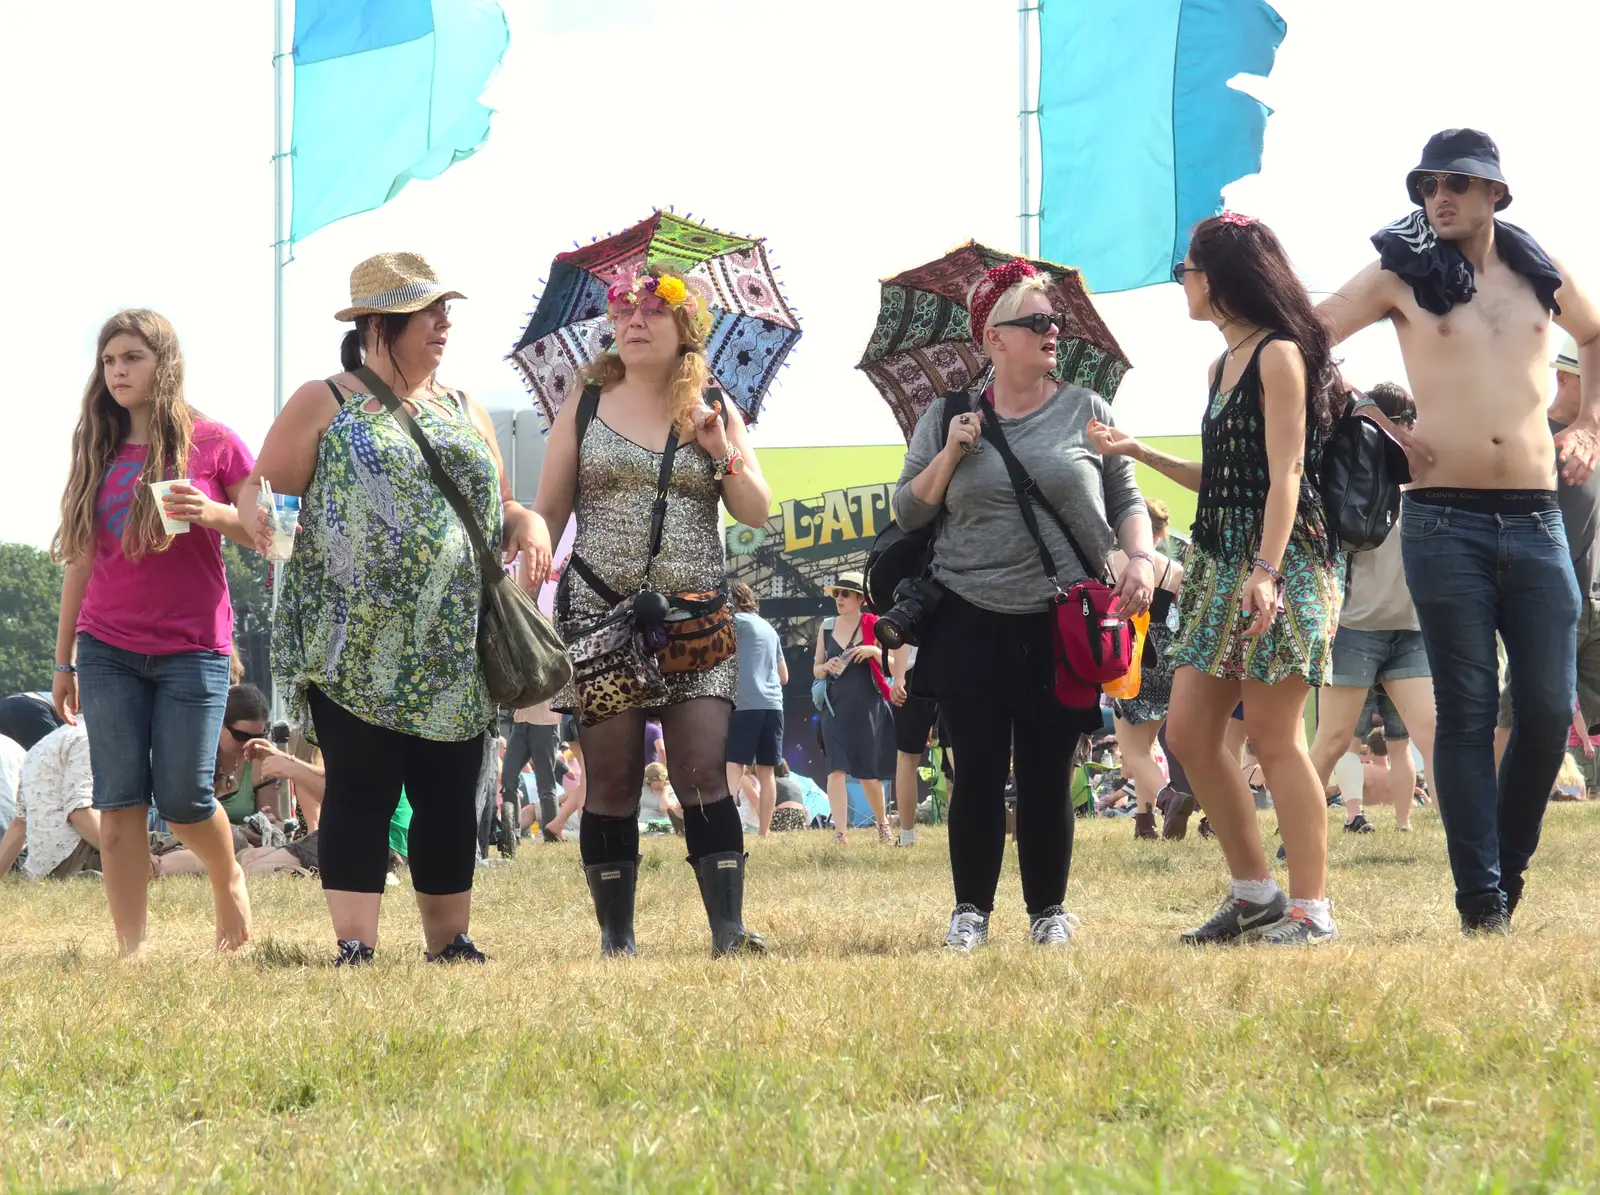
1090, 213, 1344, 945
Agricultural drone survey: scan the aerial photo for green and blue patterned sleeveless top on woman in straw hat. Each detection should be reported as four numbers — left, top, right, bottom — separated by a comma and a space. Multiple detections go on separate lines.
272, 394, 501, 742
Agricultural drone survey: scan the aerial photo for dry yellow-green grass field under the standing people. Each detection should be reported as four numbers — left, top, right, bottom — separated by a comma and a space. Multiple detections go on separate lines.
0, 805, 1600, 1192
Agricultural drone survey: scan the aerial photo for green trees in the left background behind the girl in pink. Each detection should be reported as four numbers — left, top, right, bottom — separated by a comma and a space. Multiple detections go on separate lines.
0, 539, 272, 696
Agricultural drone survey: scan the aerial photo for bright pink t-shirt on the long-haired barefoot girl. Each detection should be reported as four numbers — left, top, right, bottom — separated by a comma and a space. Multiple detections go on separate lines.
78, 421, 256, 656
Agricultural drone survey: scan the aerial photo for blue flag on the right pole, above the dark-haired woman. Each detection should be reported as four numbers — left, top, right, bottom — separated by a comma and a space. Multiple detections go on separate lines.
1038, 0, 1288, 291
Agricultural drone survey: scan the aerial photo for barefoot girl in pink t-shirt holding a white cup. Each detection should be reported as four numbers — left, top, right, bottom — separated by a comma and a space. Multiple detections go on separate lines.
53, 310, 254, 953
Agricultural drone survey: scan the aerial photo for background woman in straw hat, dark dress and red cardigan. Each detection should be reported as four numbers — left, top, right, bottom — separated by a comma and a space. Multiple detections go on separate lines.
811, 571, 894, 846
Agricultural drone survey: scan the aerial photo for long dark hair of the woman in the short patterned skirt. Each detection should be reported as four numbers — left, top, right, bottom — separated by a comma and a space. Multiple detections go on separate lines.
1189, 216, 1346, 440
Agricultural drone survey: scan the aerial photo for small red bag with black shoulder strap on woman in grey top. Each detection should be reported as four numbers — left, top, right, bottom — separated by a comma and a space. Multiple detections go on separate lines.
979, 394, 1133, 710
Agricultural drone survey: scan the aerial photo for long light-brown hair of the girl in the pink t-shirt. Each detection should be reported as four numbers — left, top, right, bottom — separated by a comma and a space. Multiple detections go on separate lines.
50, 307, 198, 562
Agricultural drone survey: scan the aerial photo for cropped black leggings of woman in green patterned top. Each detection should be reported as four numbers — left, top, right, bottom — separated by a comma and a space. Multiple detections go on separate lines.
309, 688, 483, 896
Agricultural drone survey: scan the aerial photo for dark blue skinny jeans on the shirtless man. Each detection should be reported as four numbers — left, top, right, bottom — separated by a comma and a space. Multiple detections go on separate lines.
1400, 496, 1578, 928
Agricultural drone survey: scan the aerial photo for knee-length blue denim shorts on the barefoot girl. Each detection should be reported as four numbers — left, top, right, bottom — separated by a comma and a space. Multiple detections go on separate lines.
78, 633, 229, 825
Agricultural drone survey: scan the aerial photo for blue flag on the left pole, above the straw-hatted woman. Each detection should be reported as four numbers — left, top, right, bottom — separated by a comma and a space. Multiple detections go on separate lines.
290, 0, 510, 242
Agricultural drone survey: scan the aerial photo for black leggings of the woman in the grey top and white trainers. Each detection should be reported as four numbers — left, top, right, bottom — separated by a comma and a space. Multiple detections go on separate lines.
939, 697, 1078, 917
